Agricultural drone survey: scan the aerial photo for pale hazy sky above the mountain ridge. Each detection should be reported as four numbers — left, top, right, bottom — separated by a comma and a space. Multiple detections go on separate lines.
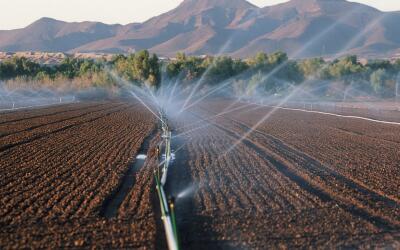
0, 0, 400, 30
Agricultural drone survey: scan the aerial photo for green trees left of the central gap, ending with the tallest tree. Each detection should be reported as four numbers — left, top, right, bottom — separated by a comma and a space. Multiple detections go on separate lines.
0, 51, 161, 87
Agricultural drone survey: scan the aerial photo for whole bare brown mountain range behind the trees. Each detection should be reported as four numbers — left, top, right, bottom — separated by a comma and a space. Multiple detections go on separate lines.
0, 0, 400, 58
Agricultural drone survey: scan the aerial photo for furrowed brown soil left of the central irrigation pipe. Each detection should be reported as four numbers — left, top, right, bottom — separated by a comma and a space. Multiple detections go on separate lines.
0, 102, 162, 249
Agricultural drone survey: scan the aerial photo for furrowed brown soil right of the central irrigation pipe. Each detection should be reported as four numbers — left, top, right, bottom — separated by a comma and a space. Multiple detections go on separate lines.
165, 100, 400, 249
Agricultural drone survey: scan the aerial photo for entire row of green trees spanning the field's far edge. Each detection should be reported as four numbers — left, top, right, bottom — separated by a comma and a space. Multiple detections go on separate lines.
0, 50, 400, 97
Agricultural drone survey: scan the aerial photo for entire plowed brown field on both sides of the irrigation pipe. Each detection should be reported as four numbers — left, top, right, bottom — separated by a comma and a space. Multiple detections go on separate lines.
0, 99, 400, 249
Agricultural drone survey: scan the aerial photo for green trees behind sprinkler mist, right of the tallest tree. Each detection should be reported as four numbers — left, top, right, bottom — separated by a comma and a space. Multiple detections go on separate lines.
166, 52, 400, 97
